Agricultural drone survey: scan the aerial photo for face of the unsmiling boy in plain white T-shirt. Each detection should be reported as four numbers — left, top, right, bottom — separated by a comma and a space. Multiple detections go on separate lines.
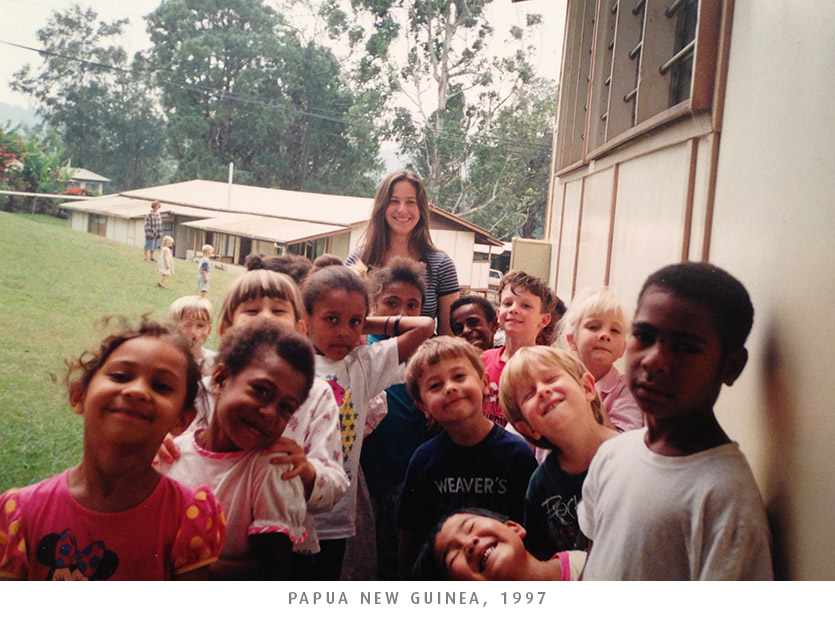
626, 285, 745, 419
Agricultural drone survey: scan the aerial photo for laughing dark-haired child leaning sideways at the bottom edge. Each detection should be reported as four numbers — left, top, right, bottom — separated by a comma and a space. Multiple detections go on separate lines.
412, 508, 586, 581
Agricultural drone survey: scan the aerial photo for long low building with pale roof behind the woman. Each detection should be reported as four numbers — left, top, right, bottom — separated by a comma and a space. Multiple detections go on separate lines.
60, 180, 503, 293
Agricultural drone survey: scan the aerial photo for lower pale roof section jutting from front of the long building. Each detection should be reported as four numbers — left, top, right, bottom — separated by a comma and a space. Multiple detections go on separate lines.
183, 214, 349, 244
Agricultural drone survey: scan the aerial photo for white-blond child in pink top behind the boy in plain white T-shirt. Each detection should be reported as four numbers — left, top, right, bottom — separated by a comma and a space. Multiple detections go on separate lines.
558, 288, 644, 431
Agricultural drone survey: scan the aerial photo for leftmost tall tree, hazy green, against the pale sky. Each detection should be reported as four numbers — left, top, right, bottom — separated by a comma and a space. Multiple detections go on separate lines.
11, 5, 164, 189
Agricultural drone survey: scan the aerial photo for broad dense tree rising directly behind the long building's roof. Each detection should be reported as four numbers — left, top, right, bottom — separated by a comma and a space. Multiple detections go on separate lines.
148, 0, 386, 193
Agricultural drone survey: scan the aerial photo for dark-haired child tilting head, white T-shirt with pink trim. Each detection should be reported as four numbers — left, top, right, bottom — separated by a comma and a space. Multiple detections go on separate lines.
160, 318, 313, 580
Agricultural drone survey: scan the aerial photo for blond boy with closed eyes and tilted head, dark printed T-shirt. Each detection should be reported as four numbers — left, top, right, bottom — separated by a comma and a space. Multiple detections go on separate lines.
499, 346, 617, 560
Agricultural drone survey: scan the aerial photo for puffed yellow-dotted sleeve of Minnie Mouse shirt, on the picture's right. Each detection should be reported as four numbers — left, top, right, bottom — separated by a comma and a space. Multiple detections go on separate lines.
171, 485, 226, 575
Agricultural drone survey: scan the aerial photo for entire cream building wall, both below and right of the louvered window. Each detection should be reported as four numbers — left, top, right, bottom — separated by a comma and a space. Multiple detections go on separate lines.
550, 0, 835, 579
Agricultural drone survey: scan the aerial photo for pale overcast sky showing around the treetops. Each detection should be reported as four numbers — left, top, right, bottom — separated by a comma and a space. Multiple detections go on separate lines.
0, 0, 566, 107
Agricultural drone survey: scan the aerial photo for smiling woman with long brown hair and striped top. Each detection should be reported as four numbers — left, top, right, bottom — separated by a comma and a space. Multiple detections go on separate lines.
345, 170, 460, 335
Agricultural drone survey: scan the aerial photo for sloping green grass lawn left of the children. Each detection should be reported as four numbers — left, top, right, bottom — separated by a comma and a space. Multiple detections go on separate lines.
0, 212, 234, 492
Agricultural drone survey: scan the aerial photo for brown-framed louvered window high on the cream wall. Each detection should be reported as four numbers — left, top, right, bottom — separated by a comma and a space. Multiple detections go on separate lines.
556, 0, 723, 171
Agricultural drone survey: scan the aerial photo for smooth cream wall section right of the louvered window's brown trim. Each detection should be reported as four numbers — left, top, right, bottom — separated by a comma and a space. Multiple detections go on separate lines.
711, 0, 835, 580
